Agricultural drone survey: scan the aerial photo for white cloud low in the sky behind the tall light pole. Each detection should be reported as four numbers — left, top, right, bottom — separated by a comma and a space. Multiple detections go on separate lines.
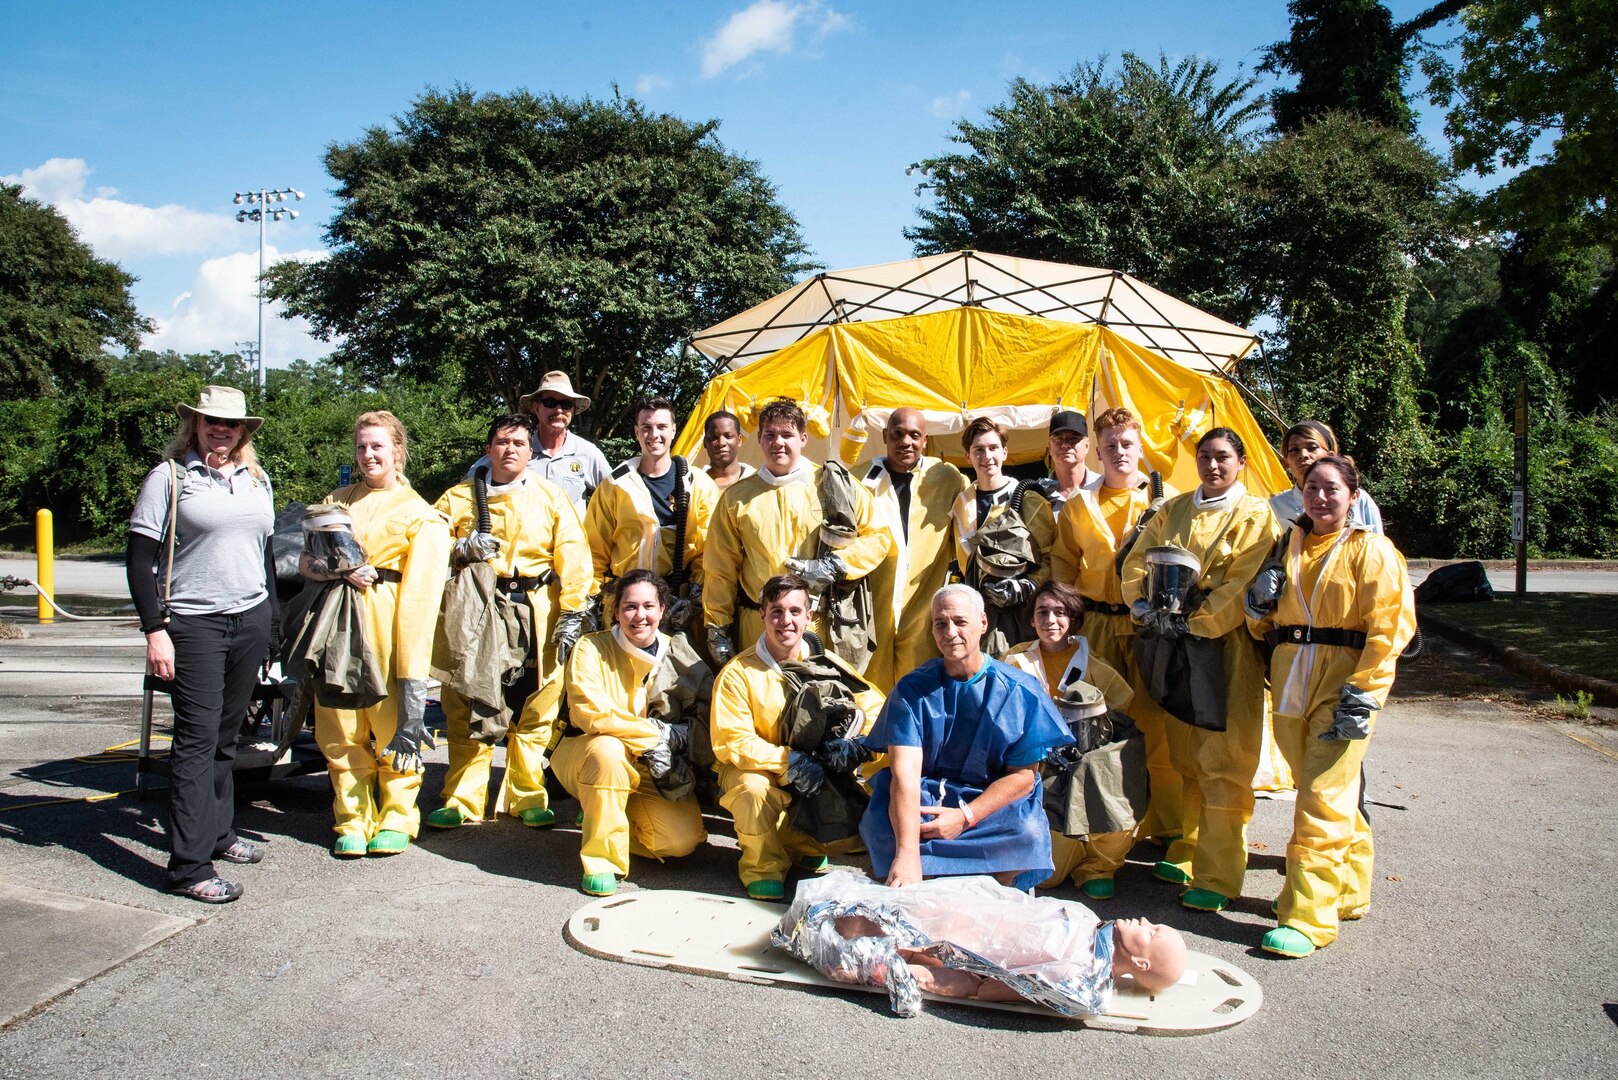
144, 246, 335, 368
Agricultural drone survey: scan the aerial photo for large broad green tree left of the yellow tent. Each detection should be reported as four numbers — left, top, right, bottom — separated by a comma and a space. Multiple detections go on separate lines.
269, 87, 811, 436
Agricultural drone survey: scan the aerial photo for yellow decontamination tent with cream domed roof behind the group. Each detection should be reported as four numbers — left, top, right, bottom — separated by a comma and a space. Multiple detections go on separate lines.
675, 253, 1290, 494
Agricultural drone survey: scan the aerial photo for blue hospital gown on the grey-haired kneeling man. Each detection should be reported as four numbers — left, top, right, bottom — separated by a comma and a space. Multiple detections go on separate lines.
859, 657, 1073, 889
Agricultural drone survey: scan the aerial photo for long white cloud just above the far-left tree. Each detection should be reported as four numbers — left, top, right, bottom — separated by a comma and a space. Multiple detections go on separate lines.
0, 157, 236, 262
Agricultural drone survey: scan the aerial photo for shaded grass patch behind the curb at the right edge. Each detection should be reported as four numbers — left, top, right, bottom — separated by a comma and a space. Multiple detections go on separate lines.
1427, 593, 1618, 678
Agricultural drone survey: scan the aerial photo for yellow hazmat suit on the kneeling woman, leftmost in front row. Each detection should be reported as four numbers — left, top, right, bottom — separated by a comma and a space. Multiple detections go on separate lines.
555, 628, 707, 878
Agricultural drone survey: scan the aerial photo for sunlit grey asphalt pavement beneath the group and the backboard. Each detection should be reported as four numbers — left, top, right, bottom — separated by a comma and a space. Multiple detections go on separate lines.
0, 625, 1618, 1080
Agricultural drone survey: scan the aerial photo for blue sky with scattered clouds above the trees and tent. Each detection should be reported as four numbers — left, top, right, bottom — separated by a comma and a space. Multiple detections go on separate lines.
0, 0, 1462, 364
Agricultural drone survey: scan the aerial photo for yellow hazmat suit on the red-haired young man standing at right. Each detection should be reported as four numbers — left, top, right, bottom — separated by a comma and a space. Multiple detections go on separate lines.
1050, 478, 1183, 837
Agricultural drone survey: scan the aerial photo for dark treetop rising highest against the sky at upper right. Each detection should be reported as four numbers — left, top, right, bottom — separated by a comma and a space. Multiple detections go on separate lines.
1259, 0, 1466, 133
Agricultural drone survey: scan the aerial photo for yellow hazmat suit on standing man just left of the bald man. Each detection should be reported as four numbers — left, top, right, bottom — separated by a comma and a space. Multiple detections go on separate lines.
702, 460, 892, 649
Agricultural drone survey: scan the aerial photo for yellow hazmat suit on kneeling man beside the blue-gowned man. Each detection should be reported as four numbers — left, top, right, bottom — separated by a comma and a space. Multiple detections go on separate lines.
710, 641, 883, 886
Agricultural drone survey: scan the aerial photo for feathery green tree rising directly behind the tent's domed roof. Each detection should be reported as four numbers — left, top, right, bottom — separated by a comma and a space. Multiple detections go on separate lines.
904, 53, 1264, 322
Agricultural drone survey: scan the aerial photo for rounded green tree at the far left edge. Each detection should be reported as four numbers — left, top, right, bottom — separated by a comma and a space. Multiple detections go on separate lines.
0, 185, 152, 397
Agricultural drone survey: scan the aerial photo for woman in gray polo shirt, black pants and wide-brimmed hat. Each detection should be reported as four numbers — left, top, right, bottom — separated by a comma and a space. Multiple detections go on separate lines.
128, 387, 277, 904
